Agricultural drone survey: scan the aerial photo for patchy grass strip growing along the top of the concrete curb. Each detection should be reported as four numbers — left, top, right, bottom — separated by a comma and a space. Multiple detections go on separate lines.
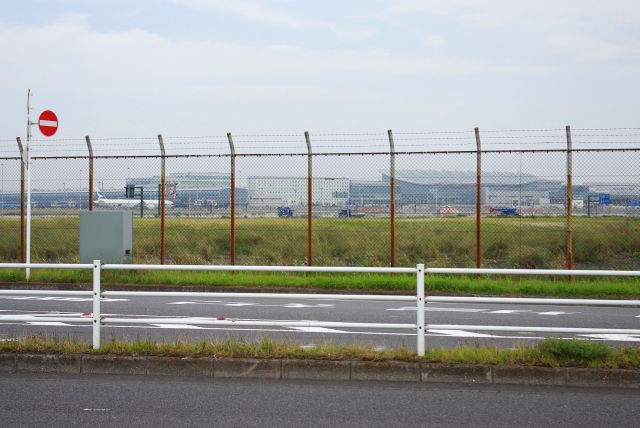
0, 336, 640, 369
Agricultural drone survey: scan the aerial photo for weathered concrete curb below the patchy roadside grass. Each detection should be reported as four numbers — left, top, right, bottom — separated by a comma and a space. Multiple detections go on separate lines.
0, 353, 640, 389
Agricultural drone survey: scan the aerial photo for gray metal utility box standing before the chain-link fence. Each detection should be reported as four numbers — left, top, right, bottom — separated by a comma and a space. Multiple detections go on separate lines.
80, 211, 133, 263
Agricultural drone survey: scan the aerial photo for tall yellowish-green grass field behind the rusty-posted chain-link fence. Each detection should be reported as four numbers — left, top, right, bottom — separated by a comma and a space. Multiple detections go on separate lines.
0, 217, 640, 269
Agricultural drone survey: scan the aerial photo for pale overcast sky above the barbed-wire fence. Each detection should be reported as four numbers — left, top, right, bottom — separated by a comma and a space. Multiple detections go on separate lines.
0, 0, 640, 144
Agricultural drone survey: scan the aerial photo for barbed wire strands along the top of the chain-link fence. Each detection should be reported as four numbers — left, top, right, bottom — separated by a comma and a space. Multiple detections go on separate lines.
5, 127, 640, 158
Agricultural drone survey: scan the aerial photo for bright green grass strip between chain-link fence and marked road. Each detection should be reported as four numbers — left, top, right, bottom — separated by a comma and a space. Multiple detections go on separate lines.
0, 269, 640, 299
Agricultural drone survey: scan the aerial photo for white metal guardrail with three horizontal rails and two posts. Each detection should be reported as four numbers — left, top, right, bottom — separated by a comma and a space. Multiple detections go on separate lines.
0, 260, 640, 356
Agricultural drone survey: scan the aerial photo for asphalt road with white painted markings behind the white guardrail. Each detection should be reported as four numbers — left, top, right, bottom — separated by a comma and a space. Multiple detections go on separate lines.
0, 295, 640, 348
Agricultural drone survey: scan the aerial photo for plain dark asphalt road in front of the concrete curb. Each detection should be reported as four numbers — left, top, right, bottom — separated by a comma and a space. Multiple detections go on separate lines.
0, 374, 640, 427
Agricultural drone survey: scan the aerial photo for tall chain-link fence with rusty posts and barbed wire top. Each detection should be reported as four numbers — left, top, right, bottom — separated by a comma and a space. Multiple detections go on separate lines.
0, 128, 640, 268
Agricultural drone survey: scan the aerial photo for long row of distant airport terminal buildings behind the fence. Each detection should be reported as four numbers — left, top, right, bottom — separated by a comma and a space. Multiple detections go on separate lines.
6, 170, 640, 215
